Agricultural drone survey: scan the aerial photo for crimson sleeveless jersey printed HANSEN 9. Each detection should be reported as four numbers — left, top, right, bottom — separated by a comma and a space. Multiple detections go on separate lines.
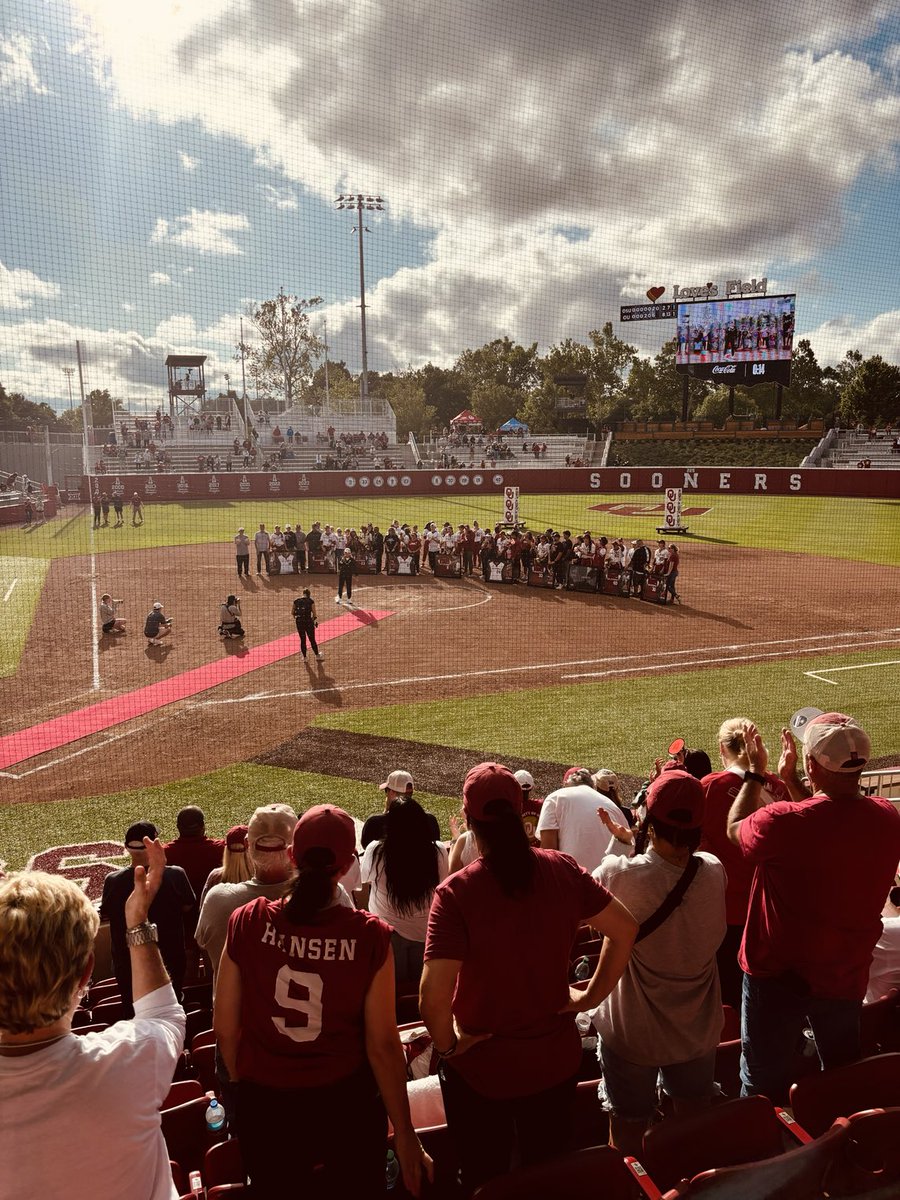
227, 896, 391, 1087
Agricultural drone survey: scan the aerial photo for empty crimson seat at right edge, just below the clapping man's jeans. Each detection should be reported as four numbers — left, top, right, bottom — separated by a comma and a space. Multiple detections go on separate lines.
791, 1054, 900, 1138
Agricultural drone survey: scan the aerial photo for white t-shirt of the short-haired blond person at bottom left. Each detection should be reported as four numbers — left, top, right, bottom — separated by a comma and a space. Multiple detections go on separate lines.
0, 984, 185, 1200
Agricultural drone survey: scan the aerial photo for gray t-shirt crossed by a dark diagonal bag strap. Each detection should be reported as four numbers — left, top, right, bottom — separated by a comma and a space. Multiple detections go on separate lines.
592, 848, 725, 1067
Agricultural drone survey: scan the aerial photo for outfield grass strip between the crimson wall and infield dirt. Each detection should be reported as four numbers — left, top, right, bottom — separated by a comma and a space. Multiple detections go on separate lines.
0, 492, 900, 566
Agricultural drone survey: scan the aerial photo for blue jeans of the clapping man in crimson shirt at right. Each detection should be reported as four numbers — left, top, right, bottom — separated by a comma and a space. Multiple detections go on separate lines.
740, 974, 863, 1104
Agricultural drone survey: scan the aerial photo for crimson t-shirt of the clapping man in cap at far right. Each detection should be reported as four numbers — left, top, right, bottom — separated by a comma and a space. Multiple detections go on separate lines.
739, 793, 900, 1000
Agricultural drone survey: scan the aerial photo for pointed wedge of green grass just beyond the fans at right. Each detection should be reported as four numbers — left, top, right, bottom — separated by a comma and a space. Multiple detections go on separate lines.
314, 646, 900, 776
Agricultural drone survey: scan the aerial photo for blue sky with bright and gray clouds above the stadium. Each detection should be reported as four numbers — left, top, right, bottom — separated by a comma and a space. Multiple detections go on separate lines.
0, 0, 900, 406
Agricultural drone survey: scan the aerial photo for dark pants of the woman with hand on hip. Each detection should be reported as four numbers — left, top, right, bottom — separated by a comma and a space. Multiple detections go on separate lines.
440, 1062, 577, 1196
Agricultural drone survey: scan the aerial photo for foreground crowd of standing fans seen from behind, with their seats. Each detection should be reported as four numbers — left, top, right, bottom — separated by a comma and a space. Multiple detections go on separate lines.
0, 709, 900, 1200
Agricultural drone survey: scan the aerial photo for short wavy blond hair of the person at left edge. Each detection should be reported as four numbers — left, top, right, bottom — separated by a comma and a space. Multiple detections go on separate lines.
0, 871, 100, 1033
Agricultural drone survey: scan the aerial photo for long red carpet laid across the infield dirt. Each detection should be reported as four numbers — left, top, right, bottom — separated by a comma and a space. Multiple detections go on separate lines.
0, 608, 394, 770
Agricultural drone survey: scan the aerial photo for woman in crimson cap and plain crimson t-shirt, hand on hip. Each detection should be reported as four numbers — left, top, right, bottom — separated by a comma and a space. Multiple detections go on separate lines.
420, 763, 637, 1195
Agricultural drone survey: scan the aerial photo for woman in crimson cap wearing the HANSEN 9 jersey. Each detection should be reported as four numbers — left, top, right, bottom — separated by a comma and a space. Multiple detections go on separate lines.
214, 805, 431, 1200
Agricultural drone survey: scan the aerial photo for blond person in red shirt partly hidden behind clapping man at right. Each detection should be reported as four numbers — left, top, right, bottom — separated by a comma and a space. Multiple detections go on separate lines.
700, 716, 791, 1013
